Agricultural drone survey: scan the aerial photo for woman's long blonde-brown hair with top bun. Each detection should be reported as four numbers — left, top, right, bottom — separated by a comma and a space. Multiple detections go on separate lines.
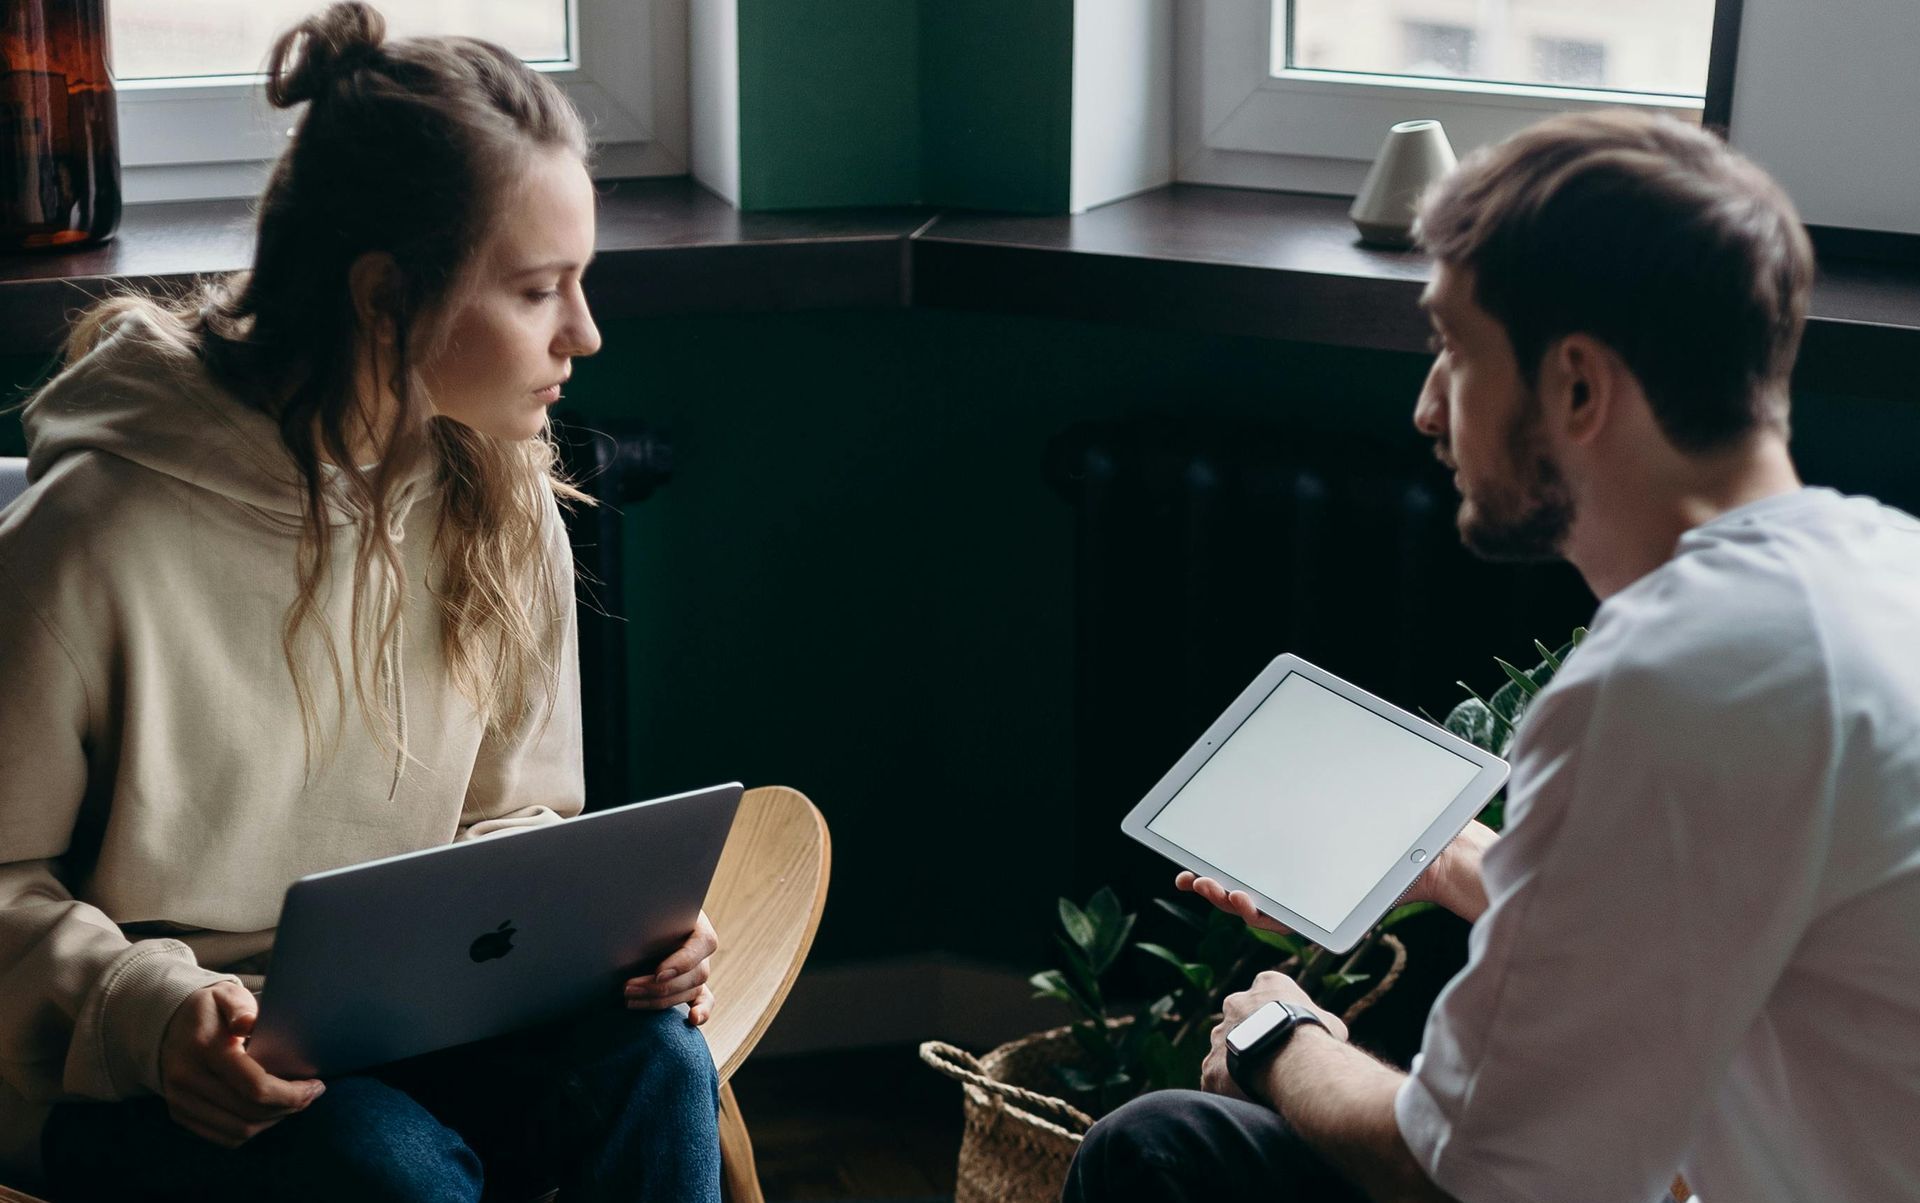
65, 0, 588, 752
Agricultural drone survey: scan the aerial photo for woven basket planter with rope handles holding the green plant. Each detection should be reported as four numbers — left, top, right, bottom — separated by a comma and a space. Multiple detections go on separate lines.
920, 934, 1407, 1203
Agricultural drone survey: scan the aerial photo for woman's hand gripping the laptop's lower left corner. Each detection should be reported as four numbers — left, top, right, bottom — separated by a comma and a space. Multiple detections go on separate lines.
159, 982, 326, 1149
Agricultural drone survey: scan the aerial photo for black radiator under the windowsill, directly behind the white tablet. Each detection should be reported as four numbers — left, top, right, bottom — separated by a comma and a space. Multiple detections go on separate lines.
1046, 416, 1594, 904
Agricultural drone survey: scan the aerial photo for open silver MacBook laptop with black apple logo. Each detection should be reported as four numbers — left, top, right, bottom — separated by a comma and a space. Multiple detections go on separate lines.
248, 783, 741, 1078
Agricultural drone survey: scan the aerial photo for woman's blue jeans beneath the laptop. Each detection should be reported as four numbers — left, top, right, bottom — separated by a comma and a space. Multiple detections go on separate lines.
40, 1007, 720, 1203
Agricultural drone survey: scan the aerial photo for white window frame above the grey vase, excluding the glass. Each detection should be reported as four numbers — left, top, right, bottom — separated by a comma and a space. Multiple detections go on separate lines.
1177, 0, 1701, 196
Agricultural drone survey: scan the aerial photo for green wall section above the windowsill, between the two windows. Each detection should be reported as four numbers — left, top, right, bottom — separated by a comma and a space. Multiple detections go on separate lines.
739, 0, 1073, 213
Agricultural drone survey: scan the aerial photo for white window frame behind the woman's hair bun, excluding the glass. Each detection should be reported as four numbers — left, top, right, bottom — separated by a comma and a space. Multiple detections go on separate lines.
115, 0, 687, 201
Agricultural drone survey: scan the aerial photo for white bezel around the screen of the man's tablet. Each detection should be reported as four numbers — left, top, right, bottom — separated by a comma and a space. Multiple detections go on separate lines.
1119, 652, 1509, 952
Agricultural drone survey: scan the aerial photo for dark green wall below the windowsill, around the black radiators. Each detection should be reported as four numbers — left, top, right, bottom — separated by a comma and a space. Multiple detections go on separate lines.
0, 311, 1920, 967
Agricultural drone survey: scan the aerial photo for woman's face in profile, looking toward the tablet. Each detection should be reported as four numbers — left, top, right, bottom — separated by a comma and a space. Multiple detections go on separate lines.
419, 148, 601, 439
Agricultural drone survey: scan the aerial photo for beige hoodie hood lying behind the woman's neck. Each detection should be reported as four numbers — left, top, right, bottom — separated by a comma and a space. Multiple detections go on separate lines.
21, 309, 432, 530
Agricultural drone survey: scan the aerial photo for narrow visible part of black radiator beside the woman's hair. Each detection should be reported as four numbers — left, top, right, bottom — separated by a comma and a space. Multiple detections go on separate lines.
553, 416, 672, 810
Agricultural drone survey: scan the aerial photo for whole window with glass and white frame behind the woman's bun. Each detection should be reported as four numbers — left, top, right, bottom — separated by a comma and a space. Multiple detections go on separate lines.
109, 0, 687, 201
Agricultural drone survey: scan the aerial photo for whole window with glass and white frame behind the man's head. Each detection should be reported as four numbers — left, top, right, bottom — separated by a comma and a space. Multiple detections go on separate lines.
1179, 0, 1715, 194
